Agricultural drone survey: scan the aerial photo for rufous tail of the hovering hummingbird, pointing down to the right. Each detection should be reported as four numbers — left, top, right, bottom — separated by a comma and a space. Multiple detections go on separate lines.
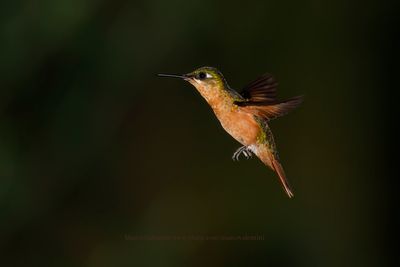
257, 145, 294, 198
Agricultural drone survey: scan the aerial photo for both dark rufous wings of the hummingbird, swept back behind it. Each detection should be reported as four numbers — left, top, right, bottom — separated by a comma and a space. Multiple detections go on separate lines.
235, 73, 303, 120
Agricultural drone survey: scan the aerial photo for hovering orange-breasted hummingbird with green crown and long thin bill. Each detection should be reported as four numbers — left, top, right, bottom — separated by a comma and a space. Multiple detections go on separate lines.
158, 67, 303, 198
